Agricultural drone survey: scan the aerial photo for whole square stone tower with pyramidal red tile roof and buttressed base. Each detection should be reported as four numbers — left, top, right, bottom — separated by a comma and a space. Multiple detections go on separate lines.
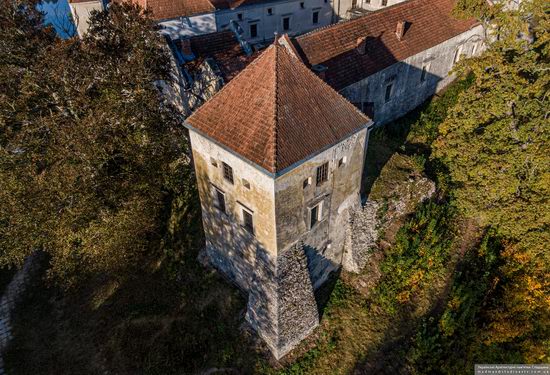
186, 44, 372, 359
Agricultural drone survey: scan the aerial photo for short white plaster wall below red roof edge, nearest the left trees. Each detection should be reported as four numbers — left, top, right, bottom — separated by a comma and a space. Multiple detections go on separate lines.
159, 12, 217, 39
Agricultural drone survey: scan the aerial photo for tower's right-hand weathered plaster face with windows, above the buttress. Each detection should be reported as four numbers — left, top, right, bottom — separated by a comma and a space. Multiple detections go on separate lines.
275, 129, 367, 288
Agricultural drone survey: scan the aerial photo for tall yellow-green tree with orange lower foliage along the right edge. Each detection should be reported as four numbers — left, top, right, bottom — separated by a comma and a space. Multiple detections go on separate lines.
433, 0, 550, 361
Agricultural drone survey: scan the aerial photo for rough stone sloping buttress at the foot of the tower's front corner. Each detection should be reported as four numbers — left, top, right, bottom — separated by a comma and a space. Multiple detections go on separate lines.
246, 243, 319, 359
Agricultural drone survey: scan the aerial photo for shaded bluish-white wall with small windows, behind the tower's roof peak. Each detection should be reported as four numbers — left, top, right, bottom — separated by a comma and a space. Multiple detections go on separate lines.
216, 0, 332, 43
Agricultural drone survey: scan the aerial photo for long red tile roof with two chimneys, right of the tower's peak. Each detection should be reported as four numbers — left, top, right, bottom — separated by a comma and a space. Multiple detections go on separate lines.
295, 0, 477, 90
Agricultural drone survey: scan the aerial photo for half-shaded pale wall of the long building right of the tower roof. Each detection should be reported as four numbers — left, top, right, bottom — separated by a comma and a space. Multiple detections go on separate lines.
341, 26, 483, 125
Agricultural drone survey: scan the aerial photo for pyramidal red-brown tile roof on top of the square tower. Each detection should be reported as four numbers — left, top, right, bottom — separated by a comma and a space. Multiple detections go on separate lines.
186, 44, 370, 173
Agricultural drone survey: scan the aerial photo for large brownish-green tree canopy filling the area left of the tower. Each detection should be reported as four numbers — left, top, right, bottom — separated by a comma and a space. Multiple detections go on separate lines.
0, 1, 187, 283
